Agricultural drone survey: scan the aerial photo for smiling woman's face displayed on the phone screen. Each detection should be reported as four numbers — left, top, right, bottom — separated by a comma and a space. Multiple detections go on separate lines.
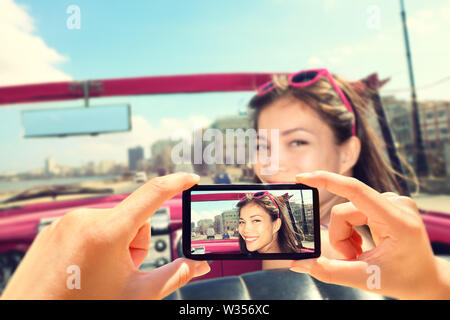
239, 202, 278, 253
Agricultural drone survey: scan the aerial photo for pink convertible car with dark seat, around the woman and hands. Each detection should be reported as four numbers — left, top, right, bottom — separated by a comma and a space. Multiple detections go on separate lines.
0, 73, 450, 300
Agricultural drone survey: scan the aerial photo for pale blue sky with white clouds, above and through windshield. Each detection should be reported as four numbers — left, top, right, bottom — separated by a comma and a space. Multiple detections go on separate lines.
0, 0, 450, 174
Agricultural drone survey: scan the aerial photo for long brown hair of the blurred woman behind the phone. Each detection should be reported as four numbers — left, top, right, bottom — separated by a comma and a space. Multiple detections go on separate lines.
249, 75, 414, 194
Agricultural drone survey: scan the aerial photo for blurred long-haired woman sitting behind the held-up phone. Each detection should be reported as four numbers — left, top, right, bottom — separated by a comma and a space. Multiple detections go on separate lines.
249, 69, 416, 267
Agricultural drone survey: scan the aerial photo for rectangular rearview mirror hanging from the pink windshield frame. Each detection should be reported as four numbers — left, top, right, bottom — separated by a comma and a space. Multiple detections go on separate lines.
22, 105, 131, 138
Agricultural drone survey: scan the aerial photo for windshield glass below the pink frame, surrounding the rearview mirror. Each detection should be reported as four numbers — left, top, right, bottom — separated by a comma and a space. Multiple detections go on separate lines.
0, 92, 253, 208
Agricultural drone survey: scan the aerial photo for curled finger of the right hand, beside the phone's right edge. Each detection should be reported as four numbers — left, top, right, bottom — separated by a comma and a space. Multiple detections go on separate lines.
328, 202, 367, 259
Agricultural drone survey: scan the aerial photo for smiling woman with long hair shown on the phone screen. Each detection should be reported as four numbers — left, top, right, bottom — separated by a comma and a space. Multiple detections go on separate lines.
237, 191, 302, 254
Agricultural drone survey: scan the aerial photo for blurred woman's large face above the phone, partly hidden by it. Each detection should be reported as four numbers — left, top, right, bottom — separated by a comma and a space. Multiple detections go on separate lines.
254, 97, 342, 208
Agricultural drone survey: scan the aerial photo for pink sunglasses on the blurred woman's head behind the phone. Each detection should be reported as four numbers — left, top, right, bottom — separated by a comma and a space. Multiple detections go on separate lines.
257, 69, 356, 136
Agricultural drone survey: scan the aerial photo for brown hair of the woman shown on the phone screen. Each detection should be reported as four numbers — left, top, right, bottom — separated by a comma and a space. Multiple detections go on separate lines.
236, 193, 303, 254
